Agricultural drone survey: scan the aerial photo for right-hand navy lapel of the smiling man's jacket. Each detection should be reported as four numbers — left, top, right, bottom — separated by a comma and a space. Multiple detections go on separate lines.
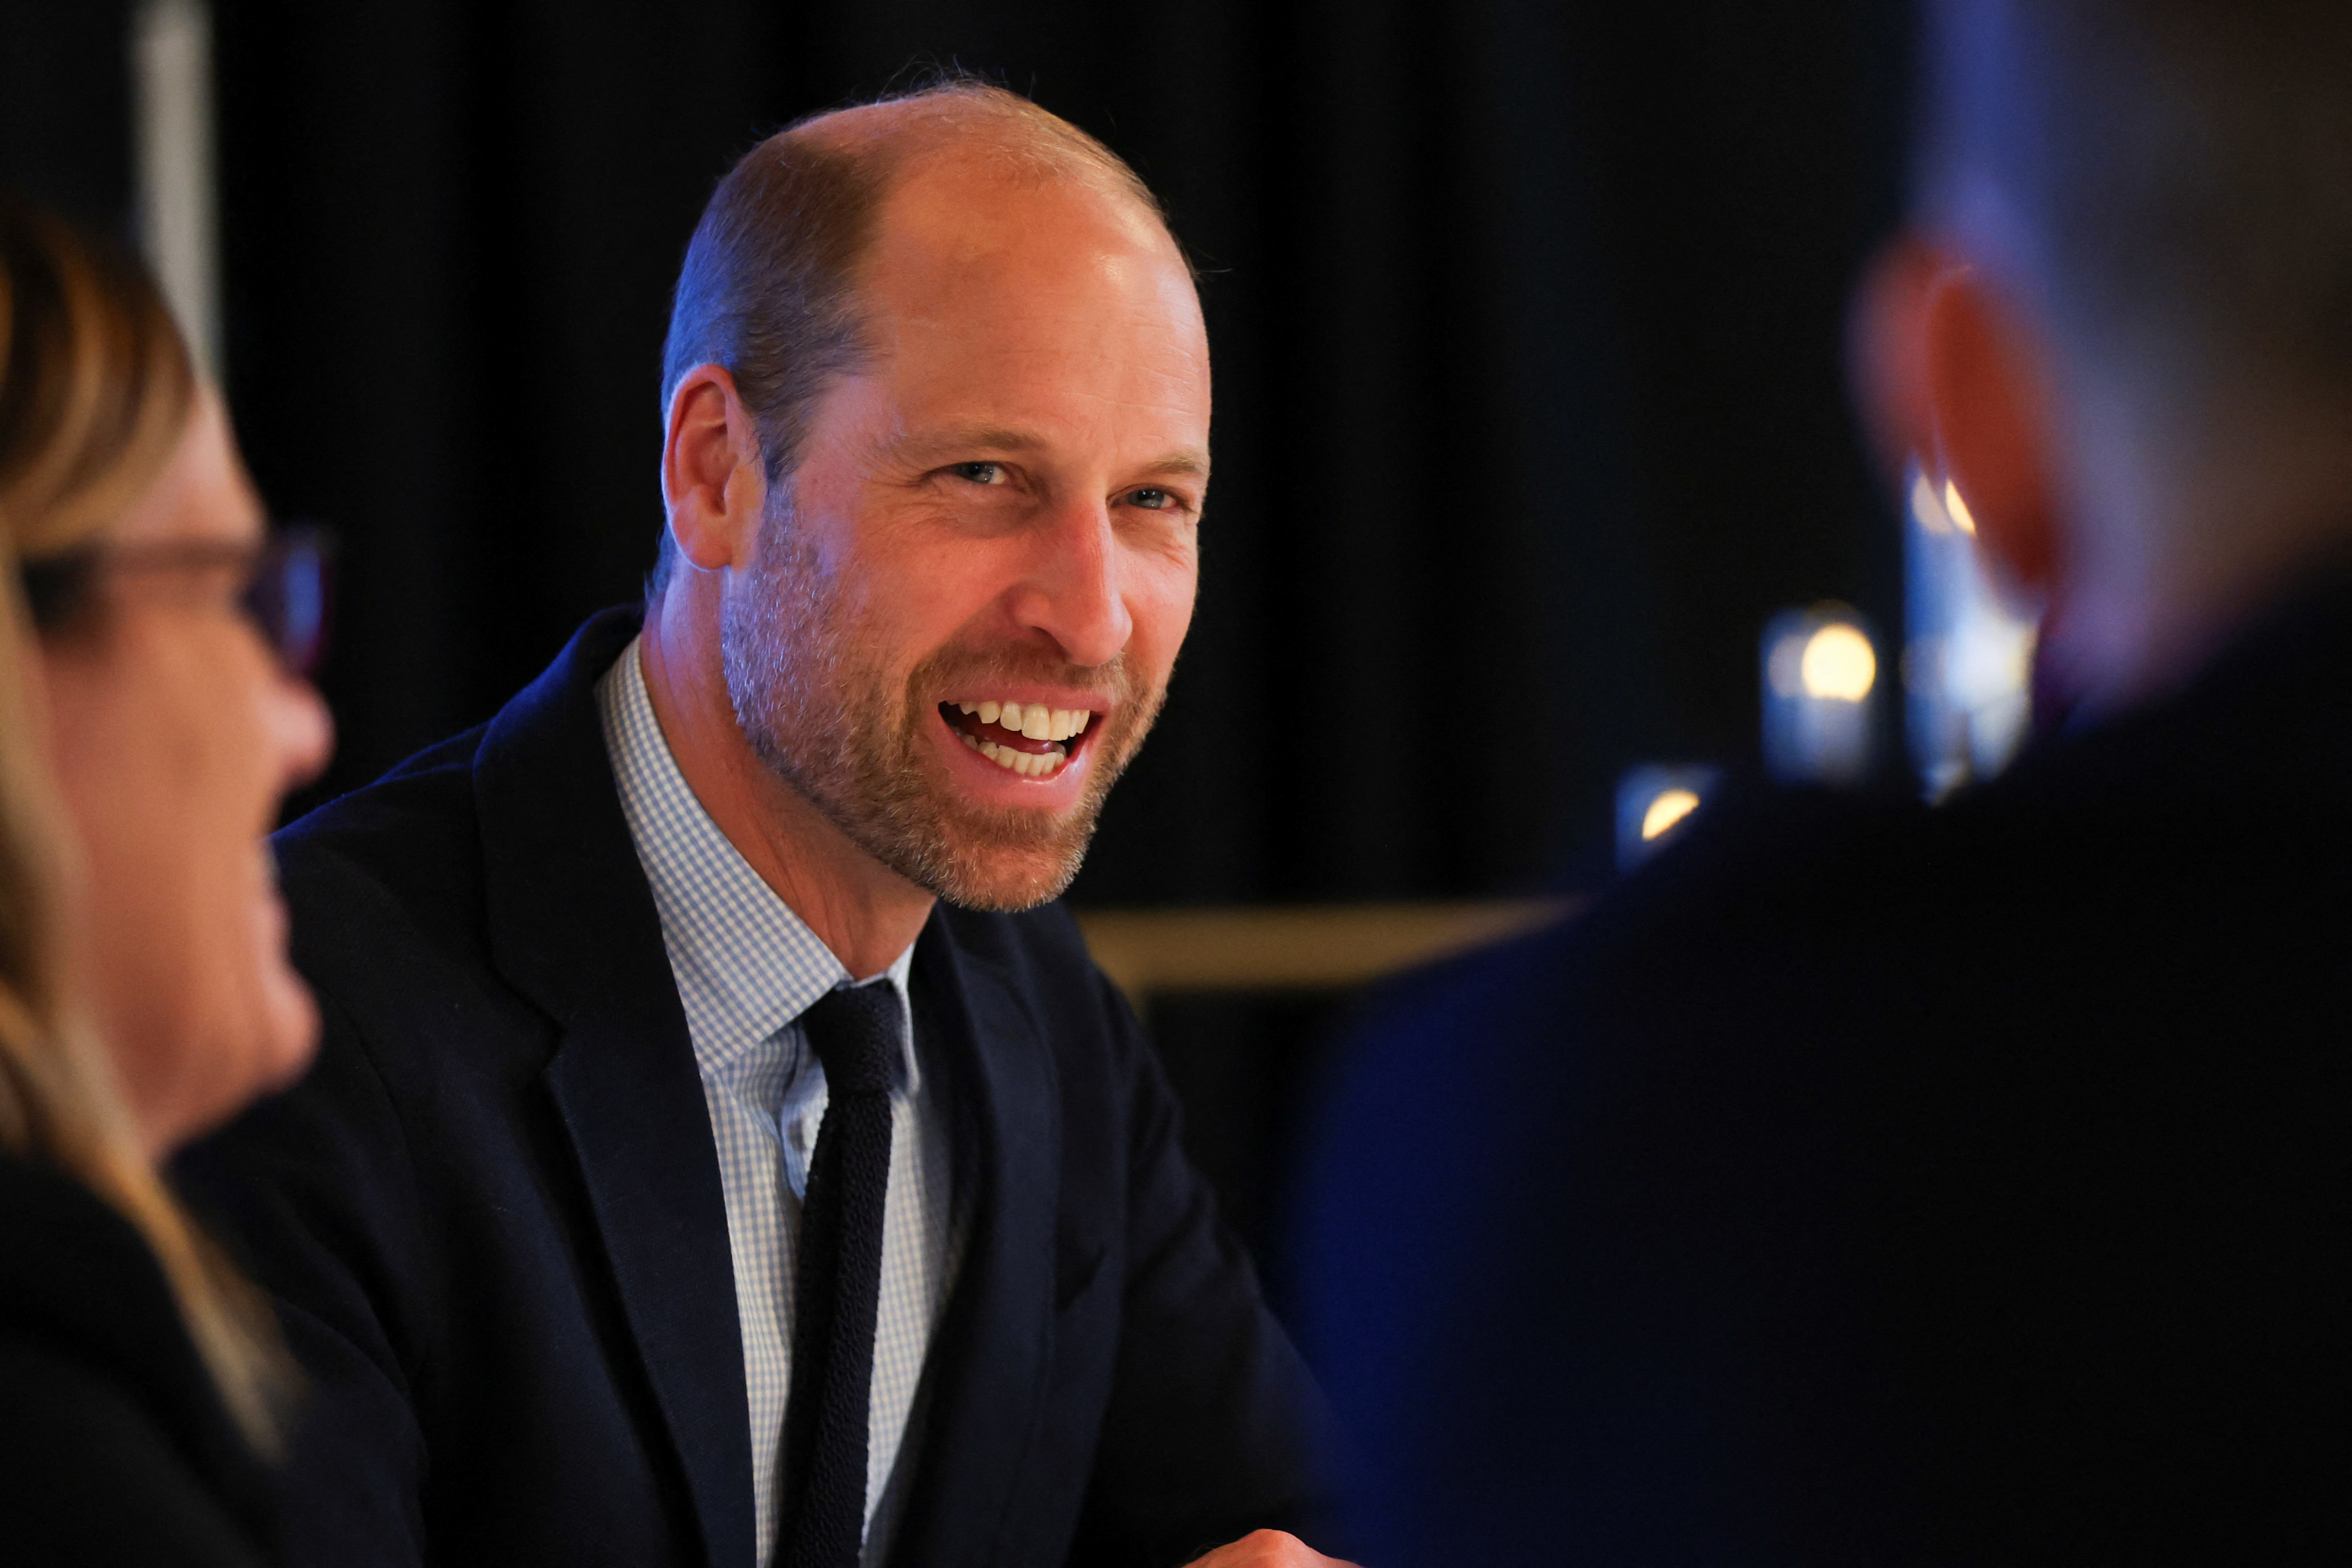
894, 910, 1061, 1566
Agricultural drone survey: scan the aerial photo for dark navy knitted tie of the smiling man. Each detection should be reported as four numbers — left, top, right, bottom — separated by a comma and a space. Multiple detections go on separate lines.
776, 982, 898, 1568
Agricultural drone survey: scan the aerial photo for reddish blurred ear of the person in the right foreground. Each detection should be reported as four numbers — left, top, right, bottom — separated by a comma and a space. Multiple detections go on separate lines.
1919, 259, 2058, 595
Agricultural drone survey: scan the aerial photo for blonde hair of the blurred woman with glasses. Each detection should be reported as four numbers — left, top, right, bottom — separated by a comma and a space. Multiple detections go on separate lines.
0, 193, 289, 1453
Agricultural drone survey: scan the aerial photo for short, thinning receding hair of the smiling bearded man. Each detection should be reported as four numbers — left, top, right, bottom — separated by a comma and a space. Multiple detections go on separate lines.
647, 75, 1167, 600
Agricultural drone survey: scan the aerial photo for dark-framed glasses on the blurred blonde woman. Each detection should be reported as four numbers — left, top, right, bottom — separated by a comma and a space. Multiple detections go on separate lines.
19, 527, 334, 675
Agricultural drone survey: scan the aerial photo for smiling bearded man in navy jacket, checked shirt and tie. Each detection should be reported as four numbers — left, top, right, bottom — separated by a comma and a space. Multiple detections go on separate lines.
188, 85, 1327, 1568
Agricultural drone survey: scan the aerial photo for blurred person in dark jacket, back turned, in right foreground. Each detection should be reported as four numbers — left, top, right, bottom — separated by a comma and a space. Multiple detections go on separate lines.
1301, 0, 2352, 1568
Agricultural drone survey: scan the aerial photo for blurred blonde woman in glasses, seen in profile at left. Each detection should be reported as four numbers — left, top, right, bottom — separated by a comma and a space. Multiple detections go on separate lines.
0, 195, 327, 1568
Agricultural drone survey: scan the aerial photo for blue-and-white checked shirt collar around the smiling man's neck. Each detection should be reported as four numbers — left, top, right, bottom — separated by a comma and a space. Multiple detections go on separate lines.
597, 639, 922, 1093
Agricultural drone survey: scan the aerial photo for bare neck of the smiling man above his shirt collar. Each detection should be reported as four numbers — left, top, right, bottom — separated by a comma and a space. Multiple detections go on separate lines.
638, 581, 936, 980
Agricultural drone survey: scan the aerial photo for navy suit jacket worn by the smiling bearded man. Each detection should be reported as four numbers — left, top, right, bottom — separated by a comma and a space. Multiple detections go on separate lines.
181, 611, 1315, 1568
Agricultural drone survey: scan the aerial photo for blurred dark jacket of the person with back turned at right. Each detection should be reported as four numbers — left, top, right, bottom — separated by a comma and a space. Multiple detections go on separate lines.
1301, 586, 2352, 1568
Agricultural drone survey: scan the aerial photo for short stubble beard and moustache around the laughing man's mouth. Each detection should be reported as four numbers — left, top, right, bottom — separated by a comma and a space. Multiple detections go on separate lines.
720, 486, 1167, 912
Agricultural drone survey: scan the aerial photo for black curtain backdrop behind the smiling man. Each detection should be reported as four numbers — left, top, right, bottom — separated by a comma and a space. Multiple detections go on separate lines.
0, 0, 1905, 1298
